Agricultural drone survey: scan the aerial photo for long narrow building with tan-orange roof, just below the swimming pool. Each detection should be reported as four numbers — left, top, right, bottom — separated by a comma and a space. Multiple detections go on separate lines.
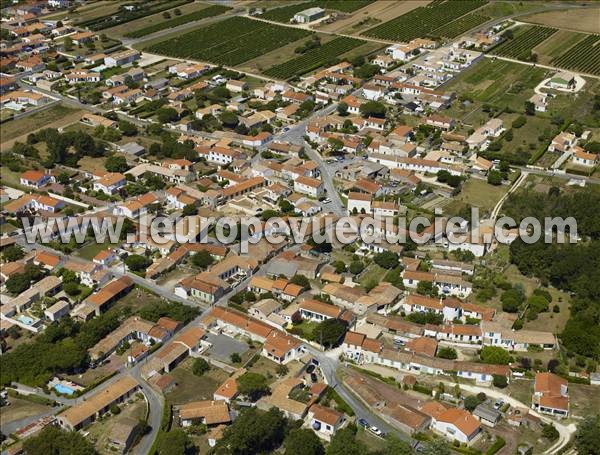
56, 376, 140, 431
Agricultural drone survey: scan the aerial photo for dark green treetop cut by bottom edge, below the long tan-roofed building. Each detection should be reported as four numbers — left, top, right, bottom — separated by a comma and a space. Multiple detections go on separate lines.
23, 425, 96, 455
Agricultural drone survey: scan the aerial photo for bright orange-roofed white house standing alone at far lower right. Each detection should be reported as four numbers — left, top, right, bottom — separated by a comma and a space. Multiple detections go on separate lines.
531, 373, 569, 417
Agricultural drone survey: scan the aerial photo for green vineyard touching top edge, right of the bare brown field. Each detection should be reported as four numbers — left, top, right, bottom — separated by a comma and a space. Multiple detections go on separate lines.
362, 0, 487, 42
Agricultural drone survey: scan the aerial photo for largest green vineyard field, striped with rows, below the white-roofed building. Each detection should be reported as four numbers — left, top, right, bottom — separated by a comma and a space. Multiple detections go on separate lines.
146, 16, 311, 66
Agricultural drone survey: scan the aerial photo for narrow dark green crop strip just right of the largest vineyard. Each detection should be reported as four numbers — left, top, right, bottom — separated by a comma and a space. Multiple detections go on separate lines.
264, 37, 365, 79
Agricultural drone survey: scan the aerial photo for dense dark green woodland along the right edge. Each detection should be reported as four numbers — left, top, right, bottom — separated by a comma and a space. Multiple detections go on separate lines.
505, 188, 600, 359
